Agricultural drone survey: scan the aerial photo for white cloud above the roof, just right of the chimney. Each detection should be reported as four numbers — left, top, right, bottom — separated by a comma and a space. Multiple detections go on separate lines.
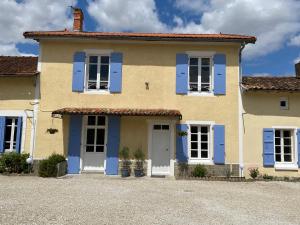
87, 0, 168, 32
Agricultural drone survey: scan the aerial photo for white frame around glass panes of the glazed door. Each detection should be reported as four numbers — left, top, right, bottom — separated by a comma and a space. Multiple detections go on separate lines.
83, 115, 108, 155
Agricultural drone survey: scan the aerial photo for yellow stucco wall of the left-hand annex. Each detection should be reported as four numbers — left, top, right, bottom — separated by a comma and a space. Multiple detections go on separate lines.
0, 76, 35, 153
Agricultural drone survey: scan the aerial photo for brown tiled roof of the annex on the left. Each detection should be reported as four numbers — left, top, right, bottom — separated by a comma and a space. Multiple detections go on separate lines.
0, 56, 38, 76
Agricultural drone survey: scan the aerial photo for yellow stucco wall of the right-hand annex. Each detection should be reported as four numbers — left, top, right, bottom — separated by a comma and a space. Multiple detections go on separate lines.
243, 92, 300, 176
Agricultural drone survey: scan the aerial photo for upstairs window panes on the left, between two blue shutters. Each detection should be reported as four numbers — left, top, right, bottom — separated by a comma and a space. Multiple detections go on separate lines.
86, 55, 110, 90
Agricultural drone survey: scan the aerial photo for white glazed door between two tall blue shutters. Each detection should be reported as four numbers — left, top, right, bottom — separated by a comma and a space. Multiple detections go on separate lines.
82, 116, 106, 172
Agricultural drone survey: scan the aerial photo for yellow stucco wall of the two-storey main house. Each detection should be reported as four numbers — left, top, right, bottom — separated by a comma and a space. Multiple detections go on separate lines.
36, 40, 239, 163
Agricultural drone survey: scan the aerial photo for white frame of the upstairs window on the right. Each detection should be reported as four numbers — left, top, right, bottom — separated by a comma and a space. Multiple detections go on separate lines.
186, 51, 216, 96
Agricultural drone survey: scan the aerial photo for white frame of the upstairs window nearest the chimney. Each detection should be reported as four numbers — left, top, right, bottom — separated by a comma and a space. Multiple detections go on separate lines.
84, 54, 111, 94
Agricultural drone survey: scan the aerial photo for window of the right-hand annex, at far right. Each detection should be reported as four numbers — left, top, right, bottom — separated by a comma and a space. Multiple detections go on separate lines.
275, 129, 294, 163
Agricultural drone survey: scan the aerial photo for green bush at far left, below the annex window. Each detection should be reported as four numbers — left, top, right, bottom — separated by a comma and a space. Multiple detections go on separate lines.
0, 152, 30, 173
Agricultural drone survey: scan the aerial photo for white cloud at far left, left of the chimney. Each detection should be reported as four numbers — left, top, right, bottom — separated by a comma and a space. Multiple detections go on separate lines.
0, 0, 76, 55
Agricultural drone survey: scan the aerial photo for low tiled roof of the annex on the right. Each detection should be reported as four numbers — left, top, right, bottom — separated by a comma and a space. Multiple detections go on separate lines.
242, 77, 300, 91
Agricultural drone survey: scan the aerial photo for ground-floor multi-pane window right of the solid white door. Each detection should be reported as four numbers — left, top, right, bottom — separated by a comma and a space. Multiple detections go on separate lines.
189, 125, 210, 160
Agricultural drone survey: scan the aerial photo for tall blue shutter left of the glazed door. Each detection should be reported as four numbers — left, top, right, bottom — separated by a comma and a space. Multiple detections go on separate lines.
68, 115, 82, 174
